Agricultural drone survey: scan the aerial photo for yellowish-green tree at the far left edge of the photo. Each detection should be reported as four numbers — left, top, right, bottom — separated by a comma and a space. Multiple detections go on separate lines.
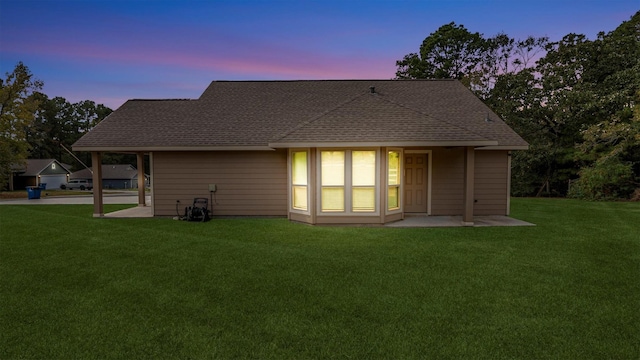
0, 62, 43, 189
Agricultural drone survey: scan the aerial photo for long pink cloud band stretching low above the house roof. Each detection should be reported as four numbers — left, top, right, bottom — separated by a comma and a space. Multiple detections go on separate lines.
12, 32, 401, 78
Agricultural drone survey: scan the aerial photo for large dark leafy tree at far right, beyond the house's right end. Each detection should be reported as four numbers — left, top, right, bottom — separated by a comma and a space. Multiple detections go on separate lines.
486, 12, 640, 197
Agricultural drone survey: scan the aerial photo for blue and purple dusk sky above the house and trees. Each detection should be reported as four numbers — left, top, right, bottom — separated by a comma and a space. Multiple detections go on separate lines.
0, 0, 640, 109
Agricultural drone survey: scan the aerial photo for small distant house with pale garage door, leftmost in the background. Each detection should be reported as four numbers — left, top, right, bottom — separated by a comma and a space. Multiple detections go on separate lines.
9, 159, 71, 190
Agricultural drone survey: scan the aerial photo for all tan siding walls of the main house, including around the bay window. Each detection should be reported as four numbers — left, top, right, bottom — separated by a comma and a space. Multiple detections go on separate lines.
152, 148, 509, 224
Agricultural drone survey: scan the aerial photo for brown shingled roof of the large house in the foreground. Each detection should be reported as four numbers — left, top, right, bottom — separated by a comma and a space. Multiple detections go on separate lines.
73, 80, 528, 151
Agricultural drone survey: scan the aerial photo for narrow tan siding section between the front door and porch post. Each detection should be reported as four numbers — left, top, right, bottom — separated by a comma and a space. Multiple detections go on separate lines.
431, 148, 464, 215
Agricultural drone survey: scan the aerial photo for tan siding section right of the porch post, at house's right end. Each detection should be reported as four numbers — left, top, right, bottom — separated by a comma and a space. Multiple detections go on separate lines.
474, 150, 509, 215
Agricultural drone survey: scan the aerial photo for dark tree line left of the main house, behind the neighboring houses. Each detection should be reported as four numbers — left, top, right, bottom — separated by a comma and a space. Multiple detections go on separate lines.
0, 62, 136, 190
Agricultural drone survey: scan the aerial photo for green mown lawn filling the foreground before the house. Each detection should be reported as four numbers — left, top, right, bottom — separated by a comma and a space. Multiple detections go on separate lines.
0, 199, 640, 359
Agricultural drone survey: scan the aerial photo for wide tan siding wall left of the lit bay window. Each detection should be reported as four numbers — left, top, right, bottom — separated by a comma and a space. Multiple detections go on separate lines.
151, 150, 288, 216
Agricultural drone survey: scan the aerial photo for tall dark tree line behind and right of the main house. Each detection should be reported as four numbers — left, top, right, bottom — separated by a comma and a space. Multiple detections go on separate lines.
396, 12, 640, 199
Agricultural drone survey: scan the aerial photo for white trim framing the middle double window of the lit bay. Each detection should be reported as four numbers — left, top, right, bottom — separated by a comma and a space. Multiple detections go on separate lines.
315, 148, 386, 216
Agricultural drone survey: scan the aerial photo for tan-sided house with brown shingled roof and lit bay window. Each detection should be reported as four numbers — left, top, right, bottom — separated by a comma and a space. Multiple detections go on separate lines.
73, 80, 528, 224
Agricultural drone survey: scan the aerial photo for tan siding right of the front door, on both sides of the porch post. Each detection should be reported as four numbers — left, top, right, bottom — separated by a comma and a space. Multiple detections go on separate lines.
431, 148, 509, 216
